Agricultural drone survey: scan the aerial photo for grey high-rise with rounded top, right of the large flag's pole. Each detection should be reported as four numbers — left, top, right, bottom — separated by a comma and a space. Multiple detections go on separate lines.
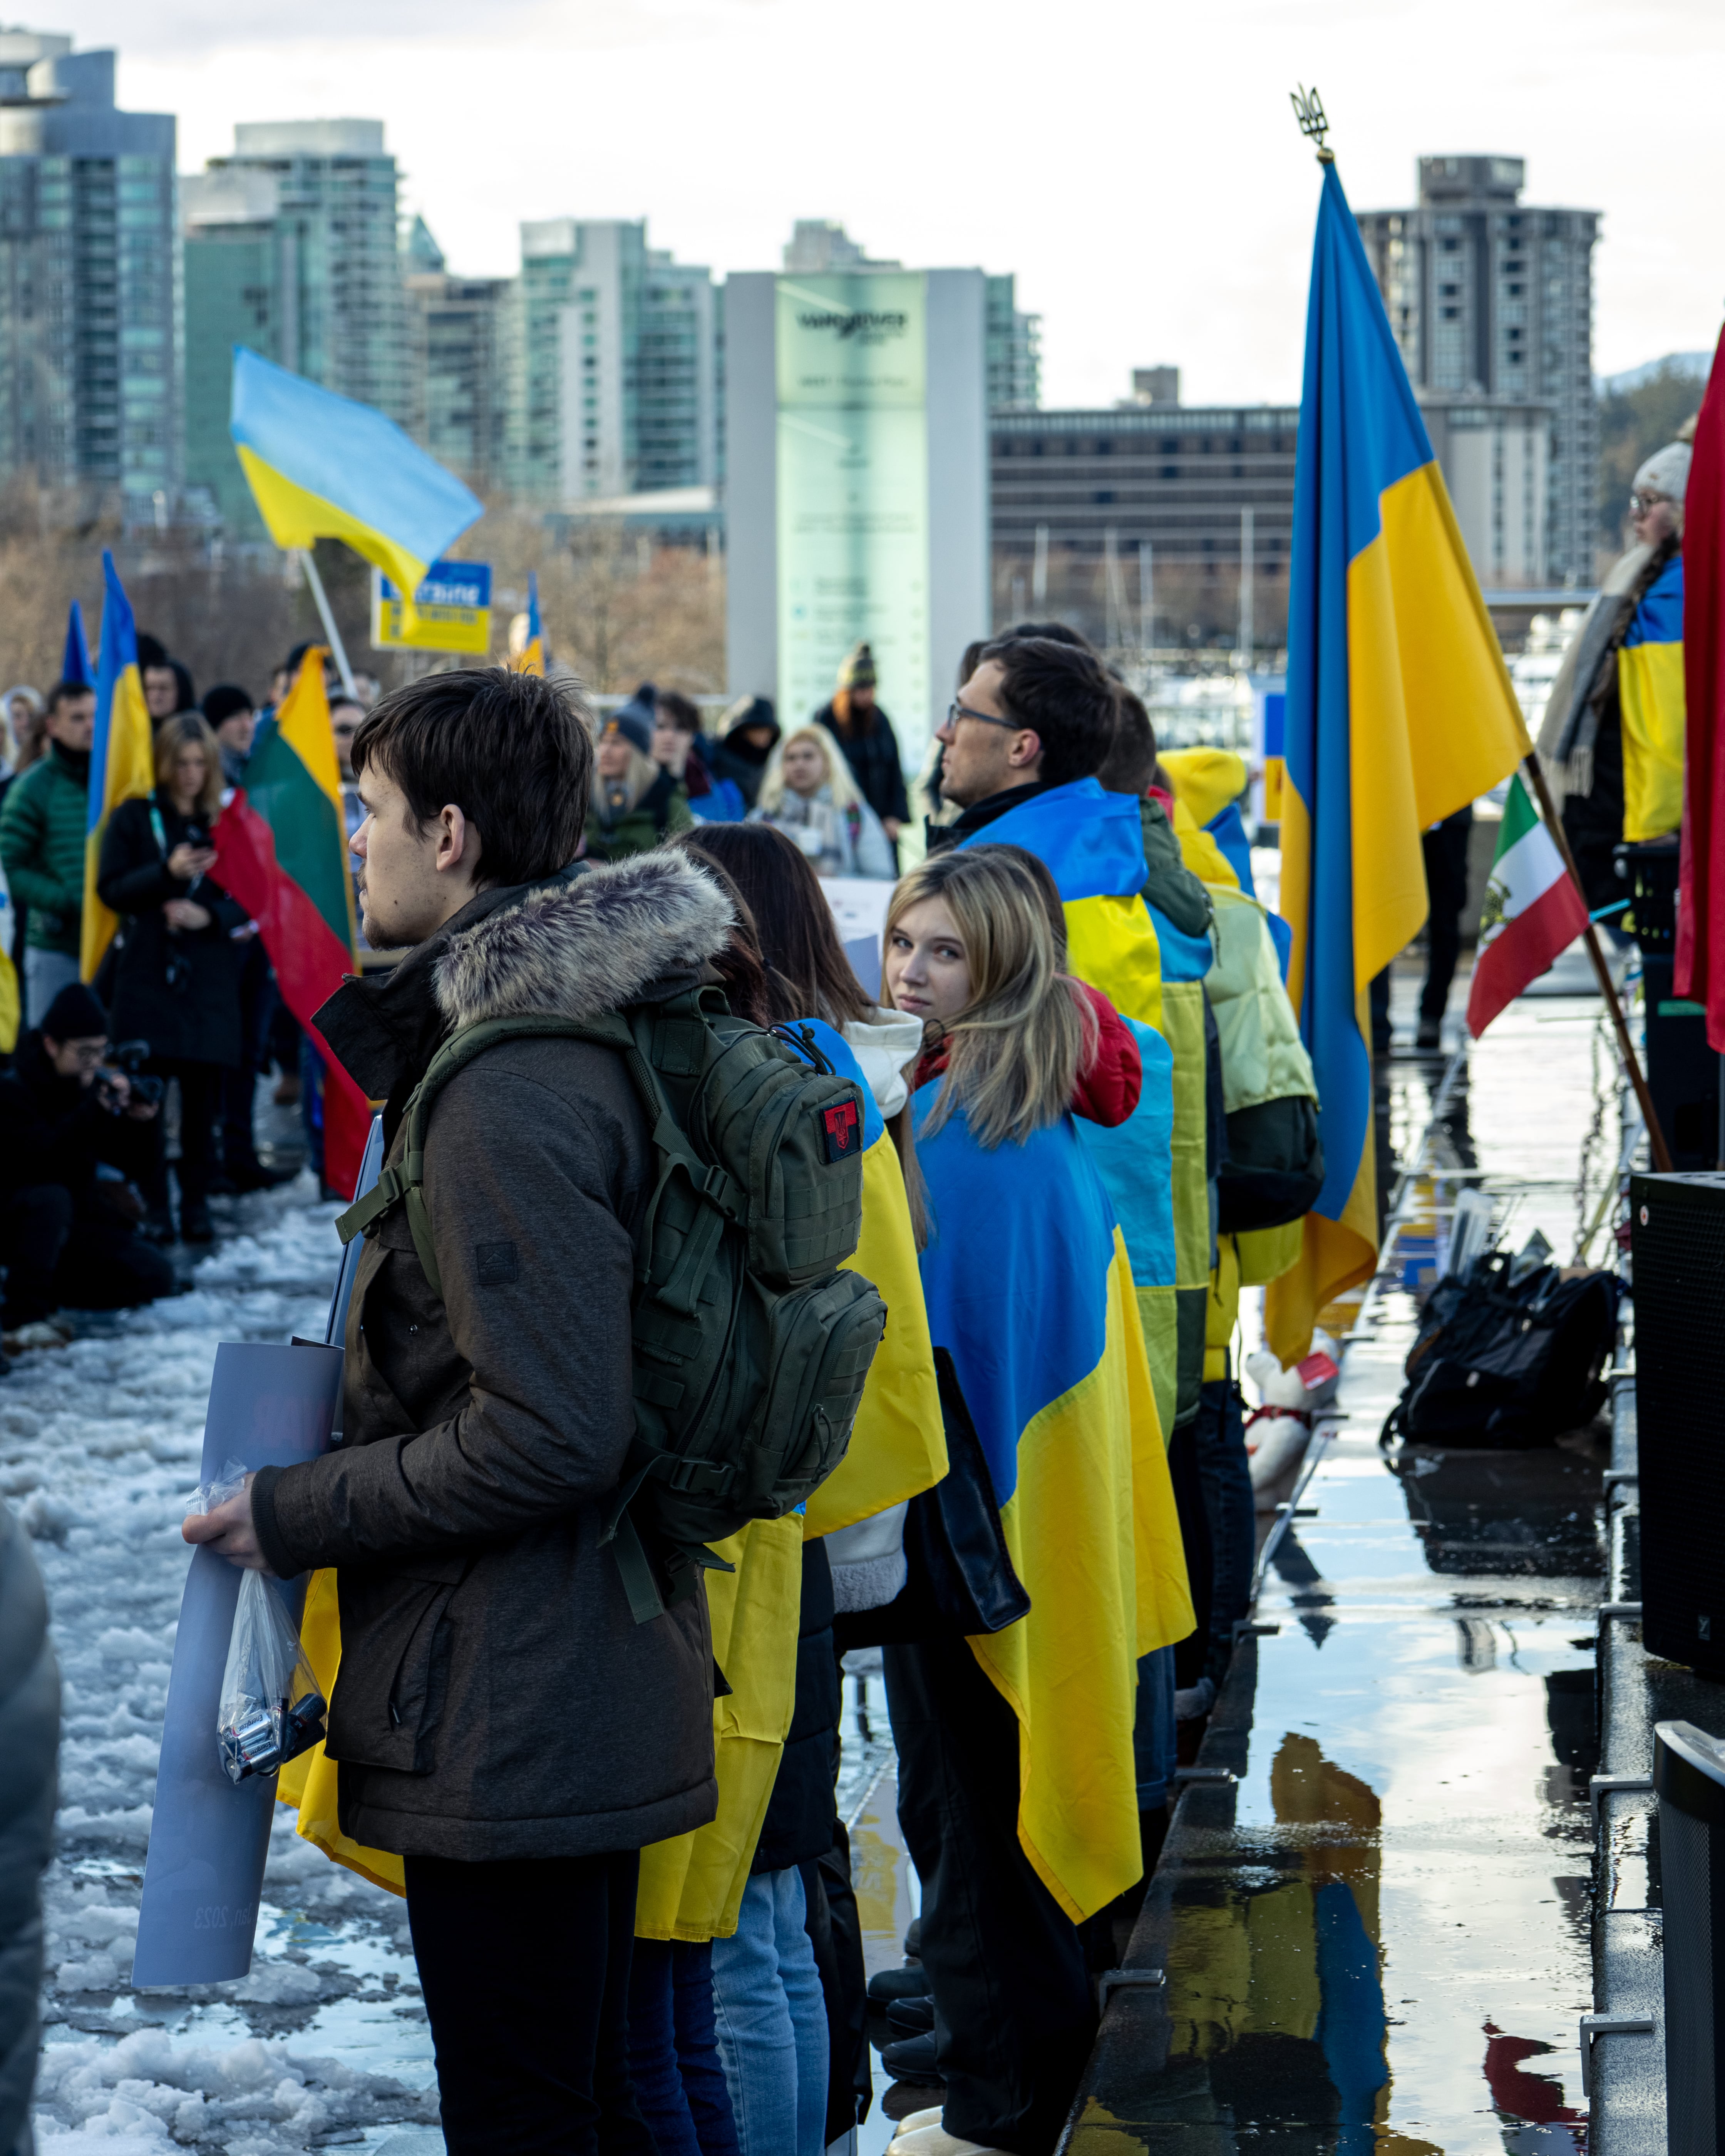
1358, 157, 1600, 584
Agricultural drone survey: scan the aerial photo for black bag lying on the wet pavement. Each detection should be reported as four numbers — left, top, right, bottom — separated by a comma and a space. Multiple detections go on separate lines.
1382, 1250, 1619, 1451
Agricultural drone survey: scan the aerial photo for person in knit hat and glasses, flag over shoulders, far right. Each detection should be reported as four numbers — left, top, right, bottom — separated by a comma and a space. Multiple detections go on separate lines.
1539, 440, 1690, 921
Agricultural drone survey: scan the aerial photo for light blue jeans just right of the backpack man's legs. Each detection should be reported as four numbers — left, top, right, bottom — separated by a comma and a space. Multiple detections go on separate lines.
714, 1865, 828, 2156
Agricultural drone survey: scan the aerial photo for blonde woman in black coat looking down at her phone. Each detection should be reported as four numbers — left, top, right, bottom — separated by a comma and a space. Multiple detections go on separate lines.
95, 711, 246, 1242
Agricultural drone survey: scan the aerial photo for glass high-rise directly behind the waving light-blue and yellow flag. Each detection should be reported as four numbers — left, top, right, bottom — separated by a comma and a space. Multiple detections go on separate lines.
181, 121, 416, 531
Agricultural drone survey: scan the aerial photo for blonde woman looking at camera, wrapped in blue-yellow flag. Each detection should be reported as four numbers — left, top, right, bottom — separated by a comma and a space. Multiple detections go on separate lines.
882, 845, 1192, 2156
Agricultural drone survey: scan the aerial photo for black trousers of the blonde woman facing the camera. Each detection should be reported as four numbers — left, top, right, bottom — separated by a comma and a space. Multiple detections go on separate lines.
884, 1639, 1095, 2156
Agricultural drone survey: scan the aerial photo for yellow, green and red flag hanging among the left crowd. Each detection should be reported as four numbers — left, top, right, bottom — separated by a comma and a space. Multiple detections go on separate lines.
212, 655, 371, 1190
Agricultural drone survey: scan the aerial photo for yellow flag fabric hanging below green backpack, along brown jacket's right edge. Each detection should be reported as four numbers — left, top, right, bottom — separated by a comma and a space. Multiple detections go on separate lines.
634, 1516, 802, 1940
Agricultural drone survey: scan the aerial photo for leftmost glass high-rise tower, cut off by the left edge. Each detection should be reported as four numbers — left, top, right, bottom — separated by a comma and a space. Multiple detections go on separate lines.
0, 30, 181, 522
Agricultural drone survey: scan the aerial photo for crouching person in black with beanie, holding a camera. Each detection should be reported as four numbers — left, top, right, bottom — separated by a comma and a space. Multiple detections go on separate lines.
0, 981, 175, 1350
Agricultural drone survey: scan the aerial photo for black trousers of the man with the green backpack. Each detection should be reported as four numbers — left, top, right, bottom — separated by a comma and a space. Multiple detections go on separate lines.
405, 1850, 655, 2156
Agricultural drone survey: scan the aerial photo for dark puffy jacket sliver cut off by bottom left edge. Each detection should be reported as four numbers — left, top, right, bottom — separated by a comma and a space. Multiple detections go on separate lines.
0, 1503, 60, 2149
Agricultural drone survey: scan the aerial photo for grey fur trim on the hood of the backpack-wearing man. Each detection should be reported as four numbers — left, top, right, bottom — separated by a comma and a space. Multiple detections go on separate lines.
434, 852, 735, 1026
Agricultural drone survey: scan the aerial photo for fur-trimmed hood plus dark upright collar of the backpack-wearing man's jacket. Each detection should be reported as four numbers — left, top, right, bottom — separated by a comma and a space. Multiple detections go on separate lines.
315, 849, 733, 1136
